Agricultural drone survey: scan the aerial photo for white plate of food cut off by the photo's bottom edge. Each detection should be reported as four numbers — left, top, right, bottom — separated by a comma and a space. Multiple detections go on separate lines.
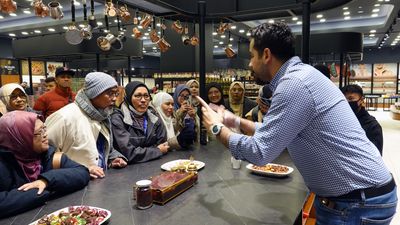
29, 206, 111, 225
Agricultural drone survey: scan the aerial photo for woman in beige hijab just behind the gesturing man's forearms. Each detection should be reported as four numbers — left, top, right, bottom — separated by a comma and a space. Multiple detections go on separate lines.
226, 81, 257, 118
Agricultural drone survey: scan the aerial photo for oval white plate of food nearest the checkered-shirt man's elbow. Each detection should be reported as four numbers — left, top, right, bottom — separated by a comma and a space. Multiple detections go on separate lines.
246, 163, 293, 177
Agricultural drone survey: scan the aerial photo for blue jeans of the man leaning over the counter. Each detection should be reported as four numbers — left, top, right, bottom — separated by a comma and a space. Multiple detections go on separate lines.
314, 187, 397, 225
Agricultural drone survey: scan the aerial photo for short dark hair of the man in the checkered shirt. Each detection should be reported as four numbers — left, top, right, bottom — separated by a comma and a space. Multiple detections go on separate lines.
251, 22, 294, 61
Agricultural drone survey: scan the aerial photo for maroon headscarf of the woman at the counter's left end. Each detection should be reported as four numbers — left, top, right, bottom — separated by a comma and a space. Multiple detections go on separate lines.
0, 110, 41, 182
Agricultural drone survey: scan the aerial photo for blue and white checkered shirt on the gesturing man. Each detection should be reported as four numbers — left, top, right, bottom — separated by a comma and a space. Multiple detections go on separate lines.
229, 56, 391, 197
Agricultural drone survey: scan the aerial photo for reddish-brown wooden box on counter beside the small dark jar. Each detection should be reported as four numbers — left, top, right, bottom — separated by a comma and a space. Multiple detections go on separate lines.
151, 172, 198, 205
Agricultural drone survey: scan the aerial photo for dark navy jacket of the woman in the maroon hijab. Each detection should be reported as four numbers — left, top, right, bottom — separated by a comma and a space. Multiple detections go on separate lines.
0, 147, 90, 218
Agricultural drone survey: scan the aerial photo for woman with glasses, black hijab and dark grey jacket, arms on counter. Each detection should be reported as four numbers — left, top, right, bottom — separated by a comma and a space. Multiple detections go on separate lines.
111, 81, 169, 164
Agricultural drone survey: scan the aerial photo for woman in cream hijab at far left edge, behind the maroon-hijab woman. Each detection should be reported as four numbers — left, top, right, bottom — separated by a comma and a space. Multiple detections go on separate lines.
0, 83, 33, 116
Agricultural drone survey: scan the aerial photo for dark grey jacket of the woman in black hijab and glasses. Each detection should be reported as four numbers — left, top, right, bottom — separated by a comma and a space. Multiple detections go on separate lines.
111, 104, 167, 164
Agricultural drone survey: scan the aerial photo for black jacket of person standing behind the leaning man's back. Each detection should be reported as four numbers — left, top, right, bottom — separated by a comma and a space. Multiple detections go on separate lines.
356, 107, 383, 155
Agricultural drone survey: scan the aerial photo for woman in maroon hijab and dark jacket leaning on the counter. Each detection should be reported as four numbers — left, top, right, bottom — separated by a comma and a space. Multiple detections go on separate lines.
0, 111, 89, 218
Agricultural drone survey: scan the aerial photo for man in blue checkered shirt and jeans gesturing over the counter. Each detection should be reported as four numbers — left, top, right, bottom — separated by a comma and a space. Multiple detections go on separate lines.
199, 23, 397, 225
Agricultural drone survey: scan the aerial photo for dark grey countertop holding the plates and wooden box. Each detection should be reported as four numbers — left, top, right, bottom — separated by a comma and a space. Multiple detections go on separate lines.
0, 141, 307, 225
